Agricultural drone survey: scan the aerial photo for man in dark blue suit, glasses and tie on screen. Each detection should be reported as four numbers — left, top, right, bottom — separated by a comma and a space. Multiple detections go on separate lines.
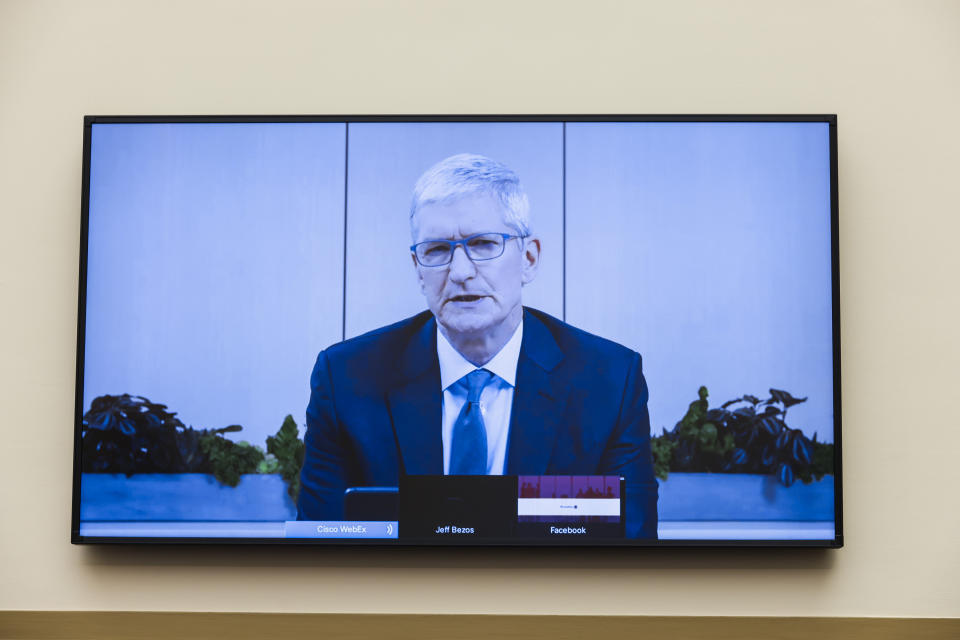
298, 154, 657, 538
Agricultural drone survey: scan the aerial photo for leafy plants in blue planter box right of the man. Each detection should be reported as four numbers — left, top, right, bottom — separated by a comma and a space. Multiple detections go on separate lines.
651, 387, 833, 521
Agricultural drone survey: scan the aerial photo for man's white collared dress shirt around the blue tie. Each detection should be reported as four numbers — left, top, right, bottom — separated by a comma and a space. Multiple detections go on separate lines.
437, 320, 523, 476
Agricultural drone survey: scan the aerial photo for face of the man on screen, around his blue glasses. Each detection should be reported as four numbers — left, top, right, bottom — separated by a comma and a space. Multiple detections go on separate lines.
413, 195, 540, 334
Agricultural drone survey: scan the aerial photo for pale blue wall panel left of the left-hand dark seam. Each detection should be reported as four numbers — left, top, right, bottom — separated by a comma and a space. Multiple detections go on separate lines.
84, 124, 345, 445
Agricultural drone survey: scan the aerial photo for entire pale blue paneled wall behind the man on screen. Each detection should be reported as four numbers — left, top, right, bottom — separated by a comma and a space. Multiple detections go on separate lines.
84, 123, 833, 444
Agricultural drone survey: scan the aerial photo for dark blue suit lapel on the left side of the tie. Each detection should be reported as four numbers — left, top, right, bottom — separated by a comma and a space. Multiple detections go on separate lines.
387, 317, 443, 475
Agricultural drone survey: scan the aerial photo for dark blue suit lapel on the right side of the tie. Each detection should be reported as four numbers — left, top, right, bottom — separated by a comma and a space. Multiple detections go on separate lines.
506, 311, 566, 475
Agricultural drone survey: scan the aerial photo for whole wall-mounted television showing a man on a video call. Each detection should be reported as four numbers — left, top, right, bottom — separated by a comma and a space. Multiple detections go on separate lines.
72, 116, 842, 546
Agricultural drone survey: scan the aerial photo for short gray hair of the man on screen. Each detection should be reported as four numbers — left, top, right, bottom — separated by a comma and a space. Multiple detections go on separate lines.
410, 153, 530, 242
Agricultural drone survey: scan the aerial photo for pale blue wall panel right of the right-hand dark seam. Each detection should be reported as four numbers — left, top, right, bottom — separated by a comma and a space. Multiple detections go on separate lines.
566, 123, 833, 441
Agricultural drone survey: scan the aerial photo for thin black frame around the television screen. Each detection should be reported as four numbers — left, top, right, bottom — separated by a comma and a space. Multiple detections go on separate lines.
70, 114, 844, 549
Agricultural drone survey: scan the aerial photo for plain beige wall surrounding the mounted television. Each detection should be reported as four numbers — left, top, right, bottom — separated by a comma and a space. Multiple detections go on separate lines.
0, 0, 960, 616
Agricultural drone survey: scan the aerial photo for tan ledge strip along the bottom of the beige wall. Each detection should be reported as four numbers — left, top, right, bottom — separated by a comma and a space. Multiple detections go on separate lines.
0, 611, 960, 640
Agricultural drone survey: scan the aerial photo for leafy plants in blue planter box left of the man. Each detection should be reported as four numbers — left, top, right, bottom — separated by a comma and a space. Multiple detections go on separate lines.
81, 394, 304, 521
